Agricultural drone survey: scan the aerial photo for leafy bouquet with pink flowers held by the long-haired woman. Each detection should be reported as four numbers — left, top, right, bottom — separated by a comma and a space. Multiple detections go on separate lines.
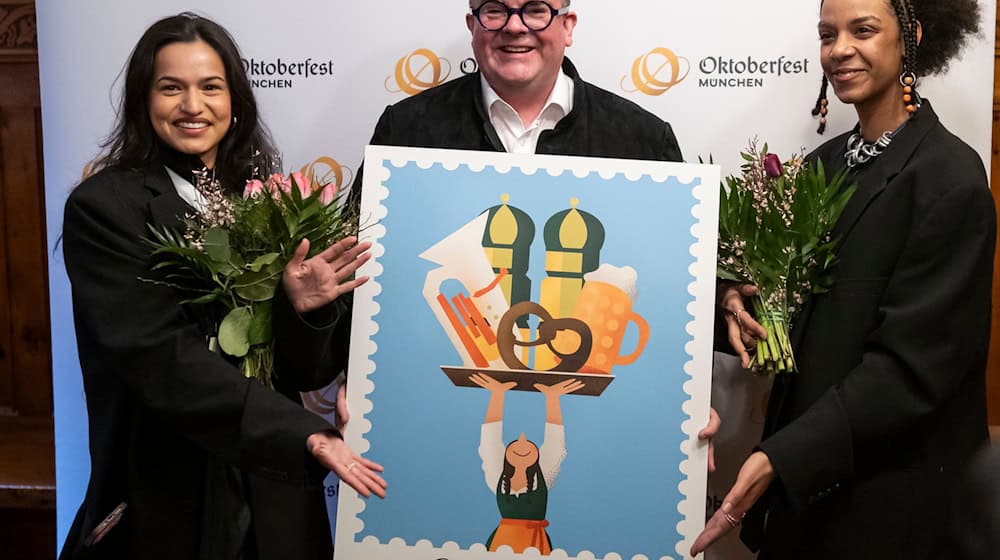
149, 172, 357, 386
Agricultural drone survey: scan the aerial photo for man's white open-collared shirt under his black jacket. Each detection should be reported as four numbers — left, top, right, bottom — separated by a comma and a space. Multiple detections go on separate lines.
479, 70, 573, 154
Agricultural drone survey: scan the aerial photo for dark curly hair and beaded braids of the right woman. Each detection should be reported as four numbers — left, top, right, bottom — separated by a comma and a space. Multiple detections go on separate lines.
812, 0, 981, 134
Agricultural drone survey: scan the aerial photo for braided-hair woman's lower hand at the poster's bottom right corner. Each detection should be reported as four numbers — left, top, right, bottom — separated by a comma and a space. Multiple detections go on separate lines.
691, 451, 774, 556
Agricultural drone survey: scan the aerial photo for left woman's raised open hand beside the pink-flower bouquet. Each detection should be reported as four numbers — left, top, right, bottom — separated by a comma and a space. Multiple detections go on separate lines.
282, 237, 371, 313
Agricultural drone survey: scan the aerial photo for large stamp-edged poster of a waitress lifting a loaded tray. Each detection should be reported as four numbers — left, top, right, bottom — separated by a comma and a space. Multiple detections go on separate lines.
335, 147, 719, 560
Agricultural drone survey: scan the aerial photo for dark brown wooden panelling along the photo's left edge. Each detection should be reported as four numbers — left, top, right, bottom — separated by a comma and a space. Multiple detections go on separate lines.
0, 0, 46, 418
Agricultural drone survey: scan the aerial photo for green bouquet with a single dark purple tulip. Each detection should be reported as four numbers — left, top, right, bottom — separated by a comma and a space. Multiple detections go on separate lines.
717, 141, 855, 375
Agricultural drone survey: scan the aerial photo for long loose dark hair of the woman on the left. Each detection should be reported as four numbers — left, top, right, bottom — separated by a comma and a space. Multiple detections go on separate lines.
93, 12, 277, 182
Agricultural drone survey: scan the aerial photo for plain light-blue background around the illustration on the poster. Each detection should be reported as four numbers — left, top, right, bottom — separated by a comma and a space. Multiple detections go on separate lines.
350, 154, 699, 558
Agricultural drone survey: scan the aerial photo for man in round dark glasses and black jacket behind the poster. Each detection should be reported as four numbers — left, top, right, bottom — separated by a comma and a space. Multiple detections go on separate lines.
354, 0, 681, 171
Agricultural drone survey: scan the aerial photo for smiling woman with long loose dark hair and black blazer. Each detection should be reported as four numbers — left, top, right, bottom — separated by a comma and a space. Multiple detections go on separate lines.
62, 13, 385, 560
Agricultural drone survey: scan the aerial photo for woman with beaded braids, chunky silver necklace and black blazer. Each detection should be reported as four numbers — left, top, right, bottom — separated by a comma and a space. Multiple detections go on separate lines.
692, 0, 996, 560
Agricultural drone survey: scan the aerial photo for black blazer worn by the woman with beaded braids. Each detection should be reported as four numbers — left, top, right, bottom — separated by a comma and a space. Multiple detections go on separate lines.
744, 102, 996, 559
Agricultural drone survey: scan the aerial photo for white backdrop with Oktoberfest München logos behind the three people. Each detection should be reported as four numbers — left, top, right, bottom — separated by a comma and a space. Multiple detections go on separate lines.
37, 0, 996, 558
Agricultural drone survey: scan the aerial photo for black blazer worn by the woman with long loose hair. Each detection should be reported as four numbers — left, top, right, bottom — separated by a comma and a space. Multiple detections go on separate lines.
62, 166, 343, 560
